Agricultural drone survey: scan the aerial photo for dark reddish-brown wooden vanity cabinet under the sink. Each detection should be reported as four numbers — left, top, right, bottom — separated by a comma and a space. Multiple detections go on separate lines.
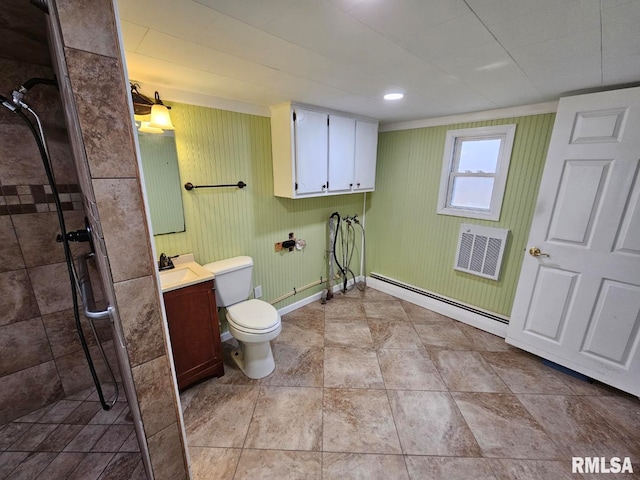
164, 280, 224, 390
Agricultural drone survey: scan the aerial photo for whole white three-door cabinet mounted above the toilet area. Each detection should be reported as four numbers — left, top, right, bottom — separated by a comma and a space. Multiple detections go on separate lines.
271, 102, 378, 198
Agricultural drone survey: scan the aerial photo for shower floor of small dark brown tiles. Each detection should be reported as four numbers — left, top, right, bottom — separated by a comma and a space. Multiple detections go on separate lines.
0, 388, 147, 480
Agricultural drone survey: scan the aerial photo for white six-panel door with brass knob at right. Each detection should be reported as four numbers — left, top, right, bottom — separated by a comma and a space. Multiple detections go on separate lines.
507, 88, 640, 395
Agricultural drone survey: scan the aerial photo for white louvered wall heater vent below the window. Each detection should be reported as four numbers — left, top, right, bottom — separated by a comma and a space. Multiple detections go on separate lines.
453, 223, 509, 280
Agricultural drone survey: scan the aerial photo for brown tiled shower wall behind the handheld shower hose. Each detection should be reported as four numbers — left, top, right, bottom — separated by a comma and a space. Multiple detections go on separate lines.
0, 54, 117, 425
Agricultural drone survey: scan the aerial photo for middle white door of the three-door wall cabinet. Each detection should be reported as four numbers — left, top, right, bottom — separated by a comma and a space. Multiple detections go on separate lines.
328, 115, 356, 193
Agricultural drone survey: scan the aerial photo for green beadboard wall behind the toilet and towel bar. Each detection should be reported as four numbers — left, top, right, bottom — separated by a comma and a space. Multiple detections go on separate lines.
147, 103, 364, 308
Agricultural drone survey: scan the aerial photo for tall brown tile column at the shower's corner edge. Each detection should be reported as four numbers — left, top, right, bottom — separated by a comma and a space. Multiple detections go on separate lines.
51, 0, 188, 479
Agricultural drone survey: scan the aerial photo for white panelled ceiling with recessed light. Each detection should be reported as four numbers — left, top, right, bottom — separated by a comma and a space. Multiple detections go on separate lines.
117, 0, 640, 123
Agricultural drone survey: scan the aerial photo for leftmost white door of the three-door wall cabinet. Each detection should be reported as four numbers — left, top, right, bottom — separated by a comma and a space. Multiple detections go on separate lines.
294, 108, 328, 195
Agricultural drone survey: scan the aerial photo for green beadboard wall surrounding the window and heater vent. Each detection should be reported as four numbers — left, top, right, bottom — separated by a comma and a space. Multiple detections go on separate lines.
366, 114, 555, 316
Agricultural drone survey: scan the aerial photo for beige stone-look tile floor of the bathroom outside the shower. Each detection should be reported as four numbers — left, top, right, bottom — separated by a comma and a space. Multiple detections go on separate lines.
181, 289, 640, 480
